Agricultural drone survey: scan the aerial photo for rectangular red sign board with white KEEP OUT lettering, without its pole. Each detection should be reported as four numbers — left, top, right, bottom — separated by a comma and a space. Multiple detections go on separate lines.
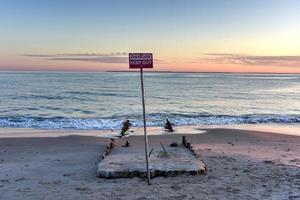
129, 53, 153, 68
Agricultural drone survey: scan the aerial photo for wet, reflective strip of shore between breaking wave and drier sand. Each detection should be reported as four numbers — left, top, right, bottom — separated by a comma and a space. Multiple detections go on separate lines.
0, 124, 300, 139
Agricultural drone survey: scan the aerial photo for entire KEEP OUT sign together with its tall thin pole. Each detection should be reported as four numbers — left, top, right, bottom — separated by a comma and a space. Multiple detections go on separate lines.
129, 53, 153, 185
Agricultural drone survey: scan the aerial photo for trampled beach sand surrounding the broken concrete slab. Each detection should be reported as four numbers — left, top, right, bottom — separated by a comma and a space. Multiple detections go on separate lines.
0, 129, 300, 200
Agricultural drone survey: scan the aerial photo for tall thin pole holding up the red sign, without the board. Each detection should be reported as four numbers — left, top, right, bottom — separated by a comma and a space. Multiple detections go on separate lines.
141, 67, 151, 185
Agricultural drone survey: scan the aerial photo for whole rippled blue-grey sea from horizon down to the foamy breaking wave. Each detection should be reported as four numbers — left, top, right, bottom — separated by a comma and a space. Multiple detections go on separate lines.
0, 72, 300, 130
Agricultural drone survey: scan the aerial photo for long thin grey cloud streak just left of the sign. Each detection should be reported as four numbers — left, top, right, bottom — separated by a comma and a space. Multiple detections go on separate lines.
22, 52, 128, 63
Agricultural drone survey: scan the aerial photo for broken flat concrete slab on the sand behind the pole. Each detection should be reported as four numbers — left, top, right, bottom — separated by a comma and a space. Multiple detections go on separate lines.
97, 144, 206, 178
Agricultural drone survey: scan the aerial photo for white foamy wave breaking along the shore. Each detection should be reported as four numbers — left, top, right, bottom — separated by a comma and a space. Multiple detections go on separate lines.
0, 113, 300, 130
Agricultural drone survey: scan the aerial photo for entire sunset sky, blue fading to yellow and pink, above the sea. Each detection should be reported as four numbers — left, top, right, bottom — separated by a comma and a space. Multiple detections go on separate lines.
0, 0, 300, 73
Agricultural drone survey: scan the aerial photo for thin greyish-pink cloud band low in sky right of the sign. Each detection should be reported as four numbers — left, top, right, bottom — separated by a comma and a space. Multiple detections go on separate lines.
202, 53, 300, 67
